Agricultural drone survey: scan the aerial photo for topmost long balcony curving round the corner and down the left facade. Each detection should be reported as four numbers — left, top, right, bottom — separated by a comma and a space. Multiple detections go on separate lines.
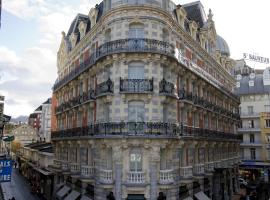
53, 38, 174, 90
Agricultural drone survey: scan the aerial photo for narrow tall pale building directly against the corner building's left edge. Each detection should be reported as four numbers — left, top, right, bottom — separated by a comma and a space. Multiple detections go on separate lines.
39, 98, 52, 142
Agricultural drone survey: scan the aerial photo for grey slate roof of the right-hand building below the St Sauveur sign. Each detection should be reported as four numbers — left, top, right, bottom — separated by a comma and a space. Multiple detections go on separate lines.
235, 74, 270, 95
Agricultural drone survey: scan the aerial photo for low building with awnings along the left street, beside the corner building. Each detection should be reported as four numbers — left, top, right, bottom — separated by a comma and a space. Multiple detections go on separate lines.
17, 142, 54, 200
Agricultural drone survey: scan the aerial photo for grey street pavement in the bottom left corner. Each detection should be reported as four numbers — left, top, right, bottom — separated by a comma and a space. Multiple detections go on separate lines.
1, 168, 40, 200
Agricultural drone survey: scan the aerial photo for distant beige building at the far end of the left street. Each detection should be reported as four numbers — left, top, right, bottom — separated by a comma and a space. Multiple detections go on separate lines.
10, 124, 38, 146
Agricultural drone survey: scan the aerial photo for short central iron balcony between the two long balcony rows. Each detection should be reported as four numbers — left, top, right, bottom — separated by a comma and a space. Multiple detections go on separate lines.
120, 78, 154, 93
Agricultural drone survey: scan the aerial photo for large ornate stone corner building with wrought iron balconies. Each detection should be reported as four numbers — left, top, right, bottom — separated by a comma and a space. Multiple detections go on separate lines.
52, 0, 241, 200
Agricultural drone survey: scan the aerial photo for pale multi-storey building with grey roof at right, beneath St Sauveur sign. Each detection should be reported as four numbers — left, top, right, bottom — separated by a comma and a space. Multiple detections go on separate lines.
235, 65, 270, 182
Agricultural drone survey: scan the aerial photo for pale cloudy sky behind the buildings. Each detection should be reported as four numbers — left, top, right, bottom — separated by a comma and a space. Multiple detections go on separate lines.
0, 0, 270, 117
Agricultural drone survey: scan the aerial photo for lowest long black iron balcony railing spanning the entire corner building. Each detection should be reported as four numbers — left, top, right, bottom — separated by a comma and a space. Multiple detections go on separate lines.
52, 122, 242, 142
